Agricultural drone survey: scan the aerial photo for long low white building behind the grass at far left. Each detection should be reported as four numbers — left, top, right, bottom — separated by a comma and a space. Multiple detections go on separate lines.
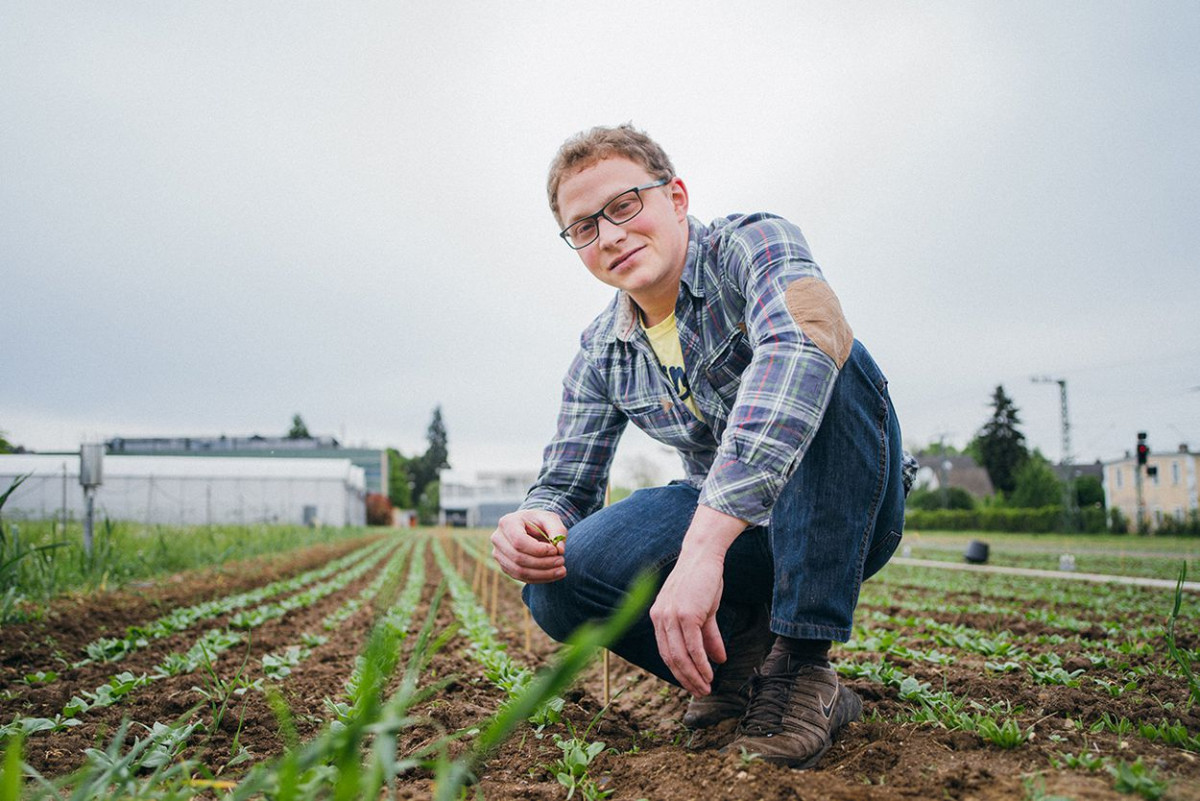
0, 453, 366, 526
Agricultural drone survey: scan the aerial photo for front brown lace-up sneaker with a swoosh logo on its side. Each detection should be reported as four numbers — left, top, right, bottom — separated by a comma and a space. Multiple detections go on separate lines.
721, 658, 863, 767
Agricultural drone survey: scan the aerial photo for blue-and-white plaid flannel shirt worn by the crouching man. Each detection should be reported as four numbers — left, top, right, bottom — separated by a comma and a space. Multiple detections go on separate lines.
521, 213, 916, 526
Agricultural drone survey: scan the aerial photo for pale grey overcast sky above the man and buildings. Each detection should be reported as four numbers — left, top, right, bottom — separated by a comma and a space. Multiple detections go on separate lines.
0, 0, 1200, 484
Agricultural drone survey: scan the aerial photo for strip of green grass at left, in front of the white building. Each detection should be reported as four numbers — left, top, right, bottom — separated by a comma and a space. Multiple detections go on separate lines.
0, 478, 379, 626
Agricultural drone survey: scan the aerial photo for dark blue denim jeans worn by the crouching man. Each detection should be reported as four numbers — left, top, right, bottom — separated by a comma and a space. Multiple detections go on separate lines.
522, 342, 905, 683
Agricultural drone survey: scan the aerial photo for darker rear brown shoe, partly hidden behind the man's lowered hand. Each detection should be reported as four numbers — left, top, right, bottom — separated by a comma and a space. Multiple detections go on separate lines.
683, 604, 775, 729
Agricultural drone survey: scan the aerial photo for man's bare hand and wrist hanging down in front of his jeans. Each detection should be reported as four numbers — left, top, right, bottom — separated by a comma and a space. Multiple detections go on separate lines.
650, 506, 746, 695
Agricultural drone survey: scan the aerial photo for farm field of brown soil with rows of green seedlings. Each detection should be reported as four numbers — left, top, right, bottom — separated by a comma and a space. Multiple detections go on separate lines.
0, 529, 1200, 801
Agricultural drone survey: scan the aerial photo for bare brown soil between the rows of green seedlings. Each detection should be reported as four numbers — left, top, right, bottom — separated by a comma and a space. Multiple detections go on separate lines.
0, 532, 1200, 801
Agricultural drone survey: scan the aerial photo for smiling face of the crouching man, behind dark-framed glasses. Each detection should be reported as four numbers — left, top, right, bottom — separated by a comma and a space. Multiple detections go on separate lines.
558, 157, 688, 303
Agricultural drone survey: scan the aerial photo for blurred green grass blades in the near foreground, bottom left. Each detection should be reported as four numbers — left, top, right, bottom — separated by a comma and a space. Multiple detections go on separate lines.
0, 576, 654, 801
